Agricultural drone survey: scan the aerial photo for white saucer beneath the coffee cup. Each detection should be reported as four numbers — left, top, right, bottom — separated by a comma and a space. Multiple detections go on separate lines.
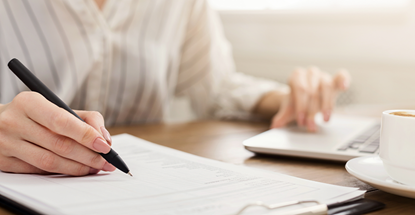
346, 155, 415, 198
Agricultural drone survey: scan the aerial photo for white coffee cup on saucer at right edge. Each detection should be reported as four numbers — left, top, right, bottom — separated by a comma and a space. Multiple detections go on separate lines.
380, 110, 415, 186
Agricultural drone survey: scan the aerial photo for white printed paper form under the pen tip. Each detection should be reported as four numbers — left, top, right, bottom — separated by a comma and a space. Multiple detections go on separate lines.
0, 134, 364, 215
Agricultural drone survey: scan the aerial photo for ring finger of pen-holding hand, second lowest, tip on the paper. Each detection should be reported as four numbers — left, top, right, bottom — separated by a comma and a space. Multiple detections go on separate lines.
14, 140, 95, 176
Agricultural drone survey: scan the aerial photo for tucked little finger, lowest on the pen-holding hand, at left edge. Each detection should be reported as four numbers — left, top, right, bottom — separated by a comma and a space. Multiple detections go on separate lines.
0, 157, 50, 174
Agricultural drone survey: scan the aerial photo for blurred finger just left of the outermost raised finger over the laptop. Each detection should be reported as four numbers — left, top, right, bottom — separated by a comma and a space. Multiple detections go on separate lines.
320, 73, 335, 122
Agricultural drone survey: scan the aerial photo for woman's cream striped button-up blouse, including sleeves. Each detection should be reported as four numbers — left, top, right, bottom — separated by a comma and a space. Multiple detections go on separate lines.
0, 0, 285, 125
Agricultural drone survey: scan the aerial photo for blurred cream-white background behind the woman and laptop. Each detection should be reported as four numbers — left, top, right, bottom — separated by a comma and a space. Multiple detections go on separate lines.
168, 0, 415, 122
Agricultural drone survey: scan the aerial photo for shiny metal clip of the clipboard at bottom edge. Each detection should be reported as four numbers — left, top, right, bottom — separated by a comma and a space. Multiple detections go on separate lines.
234, 200, 328, 215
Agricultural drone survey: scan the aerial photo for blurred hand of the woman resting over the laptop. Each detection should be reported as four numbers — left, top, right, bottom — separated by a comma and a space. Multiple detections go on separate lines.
271, 67, 350, 132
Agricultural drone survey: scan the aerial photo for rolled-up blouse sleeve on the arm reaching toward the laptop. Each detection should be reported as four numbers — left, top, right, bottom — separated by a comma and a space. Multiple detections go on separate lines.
176, 0, 288, 119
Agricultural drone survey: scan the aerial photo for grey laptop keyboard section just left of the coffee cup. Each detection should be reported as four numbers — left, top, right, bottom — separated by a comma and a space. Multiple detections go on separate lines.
338, 124, 380, 154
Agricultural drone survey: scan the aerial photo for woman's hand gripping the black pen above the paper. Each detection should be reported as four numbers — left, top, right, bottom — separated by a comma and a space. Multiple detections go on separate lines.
0, 92, 115, 176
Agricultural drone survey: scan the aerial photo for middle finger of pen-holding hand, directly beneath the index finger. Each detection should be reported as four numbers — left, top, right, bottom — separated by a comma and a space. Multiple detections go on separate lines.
21, 119, 115, 171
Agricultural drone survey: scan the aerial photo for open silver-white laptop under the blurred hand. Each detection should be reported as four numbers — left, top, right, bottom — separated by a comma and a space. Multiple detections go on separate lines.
243, 114, 380, 161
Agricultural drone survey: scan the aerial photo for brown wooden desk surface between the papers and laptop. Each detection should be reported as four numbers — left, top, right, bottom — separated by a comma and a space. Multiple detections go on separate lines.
0, 121, 415, 215
